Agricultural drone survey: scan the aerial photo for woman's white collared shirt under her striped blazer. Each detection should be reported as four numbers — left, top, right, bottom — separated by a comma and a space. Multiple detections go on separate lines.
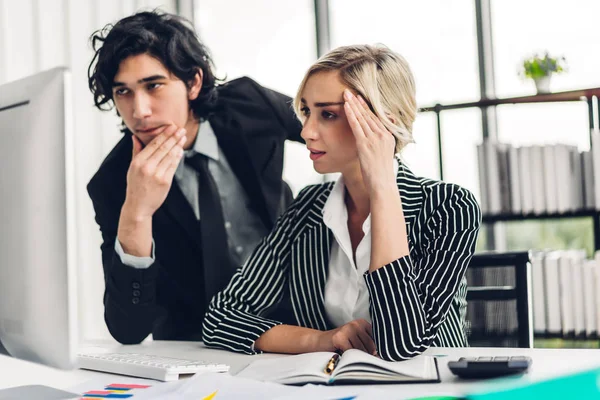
323, 158, 398, 327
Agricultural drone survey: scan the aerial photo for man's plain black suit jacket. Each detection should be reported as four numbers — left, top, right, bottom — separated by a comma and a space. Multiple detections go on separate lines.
88, 78, 302, 344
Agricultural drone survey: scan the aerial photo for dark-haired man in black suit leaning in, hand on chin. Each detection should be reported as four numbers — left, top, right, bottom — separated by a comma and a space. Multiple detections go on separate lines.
88, 11, 302, 344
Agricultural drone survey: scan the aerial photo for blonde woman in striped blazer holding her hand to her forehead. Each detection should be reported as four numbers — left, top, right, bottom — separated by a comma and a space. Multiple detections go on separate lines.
203, 45, 481, 360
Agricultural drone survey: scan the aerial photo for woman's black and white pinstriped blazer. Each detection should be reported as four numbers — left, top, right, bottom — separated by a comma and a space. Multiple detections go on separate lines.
202, 163, 481, 360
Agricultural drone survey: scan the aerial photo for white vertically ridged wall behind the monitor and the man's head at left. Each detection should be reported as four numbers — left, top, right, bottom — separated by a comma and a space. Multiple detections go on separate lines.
0, 0, 175, 339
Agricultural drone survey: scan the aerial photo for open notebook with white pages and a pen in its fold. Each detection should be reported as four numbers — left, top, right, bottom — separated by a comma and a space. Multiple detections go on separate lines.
237, 349, 440, 385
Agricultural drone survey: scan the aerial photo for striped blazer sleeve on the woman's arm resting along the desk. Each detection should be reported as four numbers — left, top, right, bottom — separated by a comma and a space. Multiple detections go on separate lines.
202, 187, 310, 354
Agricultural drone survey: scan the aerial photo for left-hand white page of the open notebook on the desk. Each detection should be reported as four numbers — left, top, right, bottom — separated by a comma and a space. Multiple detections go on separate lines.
236, 352, 335, 383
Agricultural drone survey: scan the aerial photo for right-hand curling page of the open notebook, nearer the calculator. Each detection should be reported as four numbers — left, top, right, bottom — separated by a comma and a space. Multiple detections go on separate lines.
333, 349, 437, 380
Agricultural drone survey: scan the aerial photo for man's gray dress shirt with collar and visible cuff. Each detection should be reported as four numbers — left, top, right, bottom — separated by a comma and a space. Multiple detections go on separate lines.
115, 121, 269, 268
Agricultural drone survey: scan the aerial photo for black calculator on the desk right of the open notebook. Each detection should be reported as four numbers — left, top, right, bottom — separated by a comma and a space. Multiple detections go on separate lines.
448, 356, 531, 379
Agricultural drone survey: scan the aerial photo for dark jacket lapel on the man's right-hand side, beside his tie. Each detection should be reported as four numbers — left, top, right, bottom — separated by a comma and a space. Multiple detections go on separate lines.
210, 112, 273, 228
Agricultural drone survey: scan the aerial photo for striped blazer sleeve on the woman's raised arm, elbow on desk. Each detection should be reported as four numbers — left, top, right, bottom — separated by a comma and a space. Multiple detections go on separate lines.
365, 185, 481, 361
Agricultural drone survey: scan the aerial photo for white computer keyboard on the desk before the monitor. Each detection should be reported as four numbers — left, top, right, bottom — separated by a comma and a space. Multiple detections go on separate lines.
77, 353, 229, 381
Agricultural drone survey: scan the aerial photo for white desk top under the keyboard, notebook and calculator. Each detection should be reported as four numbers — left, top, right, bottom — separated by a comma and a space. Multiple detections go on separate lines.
0, 341, 600, 395
